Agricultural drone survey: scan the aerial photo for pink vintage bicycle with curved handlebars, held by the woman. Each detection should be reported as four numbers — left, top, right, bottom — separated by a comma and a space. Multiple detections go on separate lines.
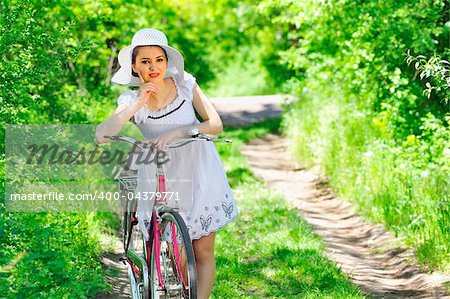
105, 132, 231, 299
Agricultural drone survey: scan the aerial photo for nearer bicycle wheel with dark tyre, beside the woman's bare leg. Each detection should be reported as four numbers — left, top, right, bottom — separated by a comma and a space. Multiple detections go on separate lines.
150, 211, 197, 299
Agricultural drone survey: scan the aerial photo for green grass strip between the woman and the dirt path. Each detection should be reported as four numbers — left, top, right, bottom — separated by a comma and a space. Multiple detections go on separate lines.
213, 119, 364, 298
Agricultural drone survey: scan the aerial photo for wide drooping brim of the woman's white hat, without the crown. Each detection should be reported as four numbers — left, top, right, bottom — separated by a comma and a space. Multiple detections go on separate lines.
111, 43, 184, 86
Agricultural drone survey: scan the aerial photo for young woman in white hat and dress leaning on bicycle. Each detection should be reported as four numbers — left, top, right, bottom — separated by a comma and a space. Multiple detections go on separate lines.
96, 28, 237, 299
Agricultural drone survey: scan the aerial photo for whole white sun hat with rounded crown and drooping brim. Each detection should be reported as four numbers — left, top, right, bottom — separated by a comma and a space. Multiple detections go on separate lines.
111, 28, 184, 86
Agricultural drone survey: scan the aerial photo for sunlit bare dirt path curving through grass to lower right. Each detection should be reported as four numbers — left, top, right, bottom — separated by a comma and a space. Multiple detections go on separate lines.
243, 135, 450, 298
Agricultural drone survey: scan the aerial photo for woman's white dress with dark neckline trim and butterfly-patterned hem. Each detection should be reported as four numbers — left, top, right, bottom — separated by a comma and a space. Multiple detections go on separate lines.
118, 72, 238, 240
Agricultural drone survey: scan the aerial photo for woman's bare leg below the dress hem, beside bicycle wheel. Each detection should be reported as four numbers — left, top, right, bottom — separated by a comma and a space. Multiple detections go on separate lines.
192, 233, 216, 299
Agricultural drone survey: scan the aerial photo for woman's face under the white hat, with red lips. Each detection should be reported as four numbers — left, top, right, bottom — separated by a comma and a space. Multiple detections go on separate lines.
132, 46, 167, 82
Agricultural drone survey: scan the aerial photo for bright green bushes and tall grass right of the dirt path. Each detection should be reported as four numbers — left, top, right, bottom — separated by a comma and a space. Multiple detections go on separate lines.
263, 0, 450, 269
